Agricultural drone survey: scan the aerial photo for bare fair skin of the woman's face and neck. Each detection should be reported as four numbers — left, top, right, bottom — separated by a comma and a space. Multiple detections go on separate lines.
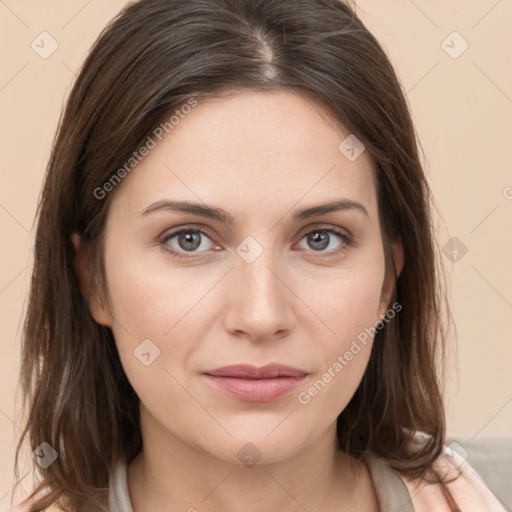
74, 91, 403, 512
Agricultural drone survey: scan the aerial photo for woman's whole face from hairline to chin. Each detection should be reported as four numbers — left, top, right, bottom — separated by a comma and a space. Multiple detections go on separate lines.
85, 91, 401, 463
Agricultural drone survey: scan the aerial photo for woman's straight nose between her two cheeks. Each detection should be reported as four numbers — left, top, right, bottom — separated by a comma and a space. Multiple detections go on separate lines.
224, 246, 297, 342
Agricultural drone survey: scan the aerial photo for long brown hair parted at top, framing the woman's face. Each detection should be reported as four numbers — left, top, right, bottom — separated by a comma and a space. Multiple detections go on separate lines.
15, 0, 450, 512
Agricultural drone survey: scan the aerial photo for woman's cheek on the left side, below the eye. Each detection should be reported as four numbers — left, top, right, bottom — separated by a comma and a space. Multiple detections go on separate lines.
101, 244, 219, 380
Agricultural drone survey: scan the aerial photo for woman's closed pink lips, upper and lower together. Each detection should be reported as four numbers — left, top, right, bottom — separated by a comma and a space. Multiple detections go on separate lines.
204, 364, 308, 402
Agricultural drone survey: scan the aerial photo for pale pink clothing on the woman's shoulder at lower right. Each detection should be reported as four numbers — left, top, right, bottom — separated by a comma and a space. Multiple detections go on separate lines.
399, 446, 505, 512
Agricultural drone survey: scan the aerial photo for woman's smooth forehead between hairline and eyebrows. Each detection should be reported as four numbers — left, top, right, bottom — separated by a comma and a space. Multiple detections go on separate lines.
110, 91, 376, 220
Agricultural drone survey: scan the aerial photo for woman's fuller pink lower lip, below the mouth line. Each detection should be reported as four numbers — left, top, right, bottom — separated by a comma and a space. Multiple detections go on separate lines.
205, 374, 306, 402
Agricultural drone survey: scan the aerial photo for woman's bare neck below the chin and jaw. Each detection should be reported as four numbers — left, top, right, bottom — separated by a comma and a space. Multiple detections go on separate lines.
128, 411, 378, 512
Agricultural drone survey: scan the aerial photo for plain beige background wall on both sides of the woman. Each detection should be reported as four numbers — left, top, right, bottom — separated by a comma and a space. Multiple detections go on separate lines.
0, 0, 512, 504
